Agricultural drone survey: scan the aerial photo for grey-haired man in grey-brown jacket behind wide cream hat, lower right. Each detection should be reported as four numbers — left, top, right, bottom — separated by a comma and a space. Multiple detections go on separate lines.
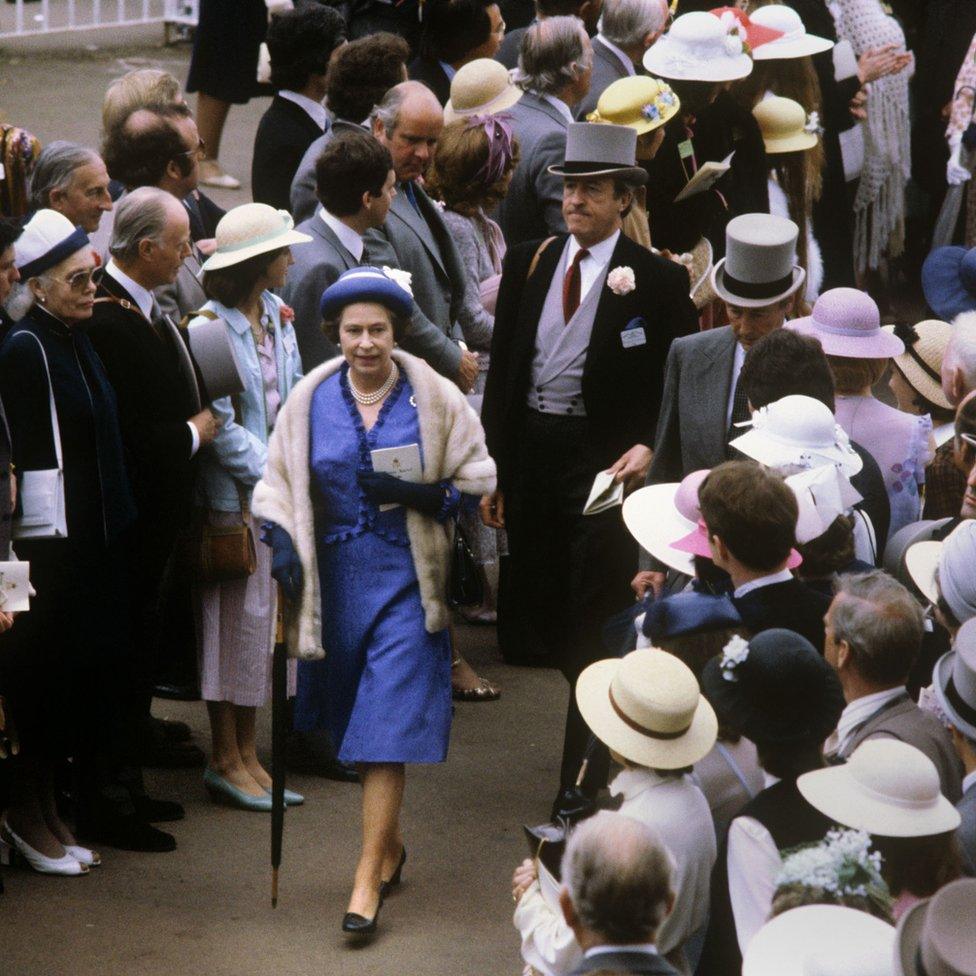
824, 569, 962, 803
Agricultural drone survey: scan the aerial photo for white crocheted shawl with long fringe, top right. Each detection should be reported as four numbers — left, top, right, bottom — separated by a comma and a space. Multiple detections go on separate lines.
831, 0, 912, 273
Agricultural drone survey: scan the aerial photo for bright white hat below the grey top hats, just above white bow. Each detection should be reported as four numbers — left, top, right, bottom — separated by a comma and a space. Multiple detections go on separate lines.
729, 394, 864, 477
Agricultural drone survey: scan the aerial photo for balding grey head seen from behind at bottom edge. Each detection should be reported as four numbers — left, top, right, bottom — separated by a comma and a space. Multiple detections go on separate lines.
562, 810, 673, 945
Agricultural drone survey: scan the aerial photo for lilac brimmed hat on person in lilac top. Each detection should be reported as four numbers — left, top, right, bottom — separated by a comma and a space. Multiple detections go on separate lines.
787, 288, 905, 359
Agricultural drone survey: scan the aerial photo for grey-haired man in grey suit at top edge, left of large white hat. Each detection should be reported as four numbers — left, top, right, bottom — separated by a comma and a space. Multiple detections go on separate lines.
575, 0, 668, 122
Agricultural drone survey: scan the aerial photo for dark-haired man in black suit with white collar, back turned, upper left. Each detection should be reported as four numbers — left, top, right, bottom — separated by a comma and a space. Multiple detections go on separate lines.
251, 3, 346, 210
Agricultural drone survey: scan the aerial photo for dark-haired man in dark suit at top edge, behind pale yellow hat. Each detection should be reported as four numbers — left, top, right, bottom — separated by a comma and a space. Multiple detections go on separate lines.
409, 0, 505, 106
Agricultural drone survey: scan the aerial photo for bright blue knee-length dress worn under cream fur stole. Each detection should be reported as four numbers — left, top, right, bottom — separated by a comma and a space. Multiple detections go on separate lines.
295, 365, 451, 763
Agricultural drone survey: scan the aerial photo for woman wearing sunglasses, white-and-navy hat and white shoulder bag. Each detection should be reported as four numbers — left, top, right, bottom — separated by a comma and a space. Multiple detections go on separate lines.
0, 210, 135, 876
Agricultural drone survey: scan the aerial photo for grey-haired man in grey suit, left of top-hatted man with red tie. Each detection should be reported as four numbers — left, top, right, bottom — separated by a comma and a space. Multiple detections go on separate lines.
496, 17, 593, 248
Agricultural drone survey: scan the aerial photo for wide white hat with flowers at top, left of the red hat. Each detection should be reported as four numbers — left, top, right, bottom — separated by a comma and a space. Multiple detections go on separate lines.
644, 11, 752, 82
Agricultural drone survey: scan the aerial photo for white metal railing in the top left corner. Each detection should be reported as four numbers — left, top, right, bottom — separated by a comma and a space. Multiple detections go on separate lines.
0, 0, 199, 40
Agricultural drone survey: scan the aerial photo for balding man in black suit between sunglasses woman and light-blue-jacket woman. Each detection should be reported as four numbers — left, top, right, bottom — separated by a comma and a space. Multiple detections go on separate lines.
88, 187, 217, 849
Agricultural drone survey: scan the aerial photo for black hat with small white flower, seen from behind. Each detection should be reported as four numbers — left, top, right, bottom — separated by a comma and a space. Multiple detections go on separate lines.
701, 628, 844, 747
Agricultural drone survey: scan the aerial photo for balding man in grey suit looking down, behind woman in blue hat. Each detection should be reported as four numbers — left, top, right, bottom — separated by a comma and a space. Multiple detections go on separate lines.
366, 81, 478, 392
